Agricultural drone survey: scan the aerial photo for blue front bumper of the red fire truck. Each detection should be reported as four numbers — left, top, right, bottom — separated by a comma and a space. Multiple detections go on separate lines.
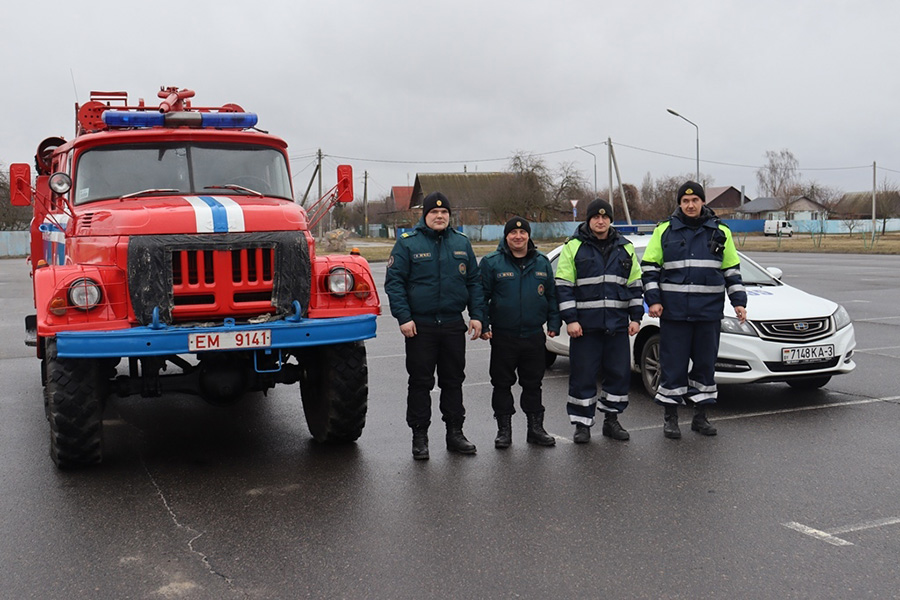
56, 315, 375, 358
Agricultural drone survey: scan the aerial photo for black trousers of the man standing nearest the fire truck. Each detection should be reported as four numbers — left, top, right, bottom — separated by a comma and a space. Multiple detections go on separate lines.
406, 320, 467, 427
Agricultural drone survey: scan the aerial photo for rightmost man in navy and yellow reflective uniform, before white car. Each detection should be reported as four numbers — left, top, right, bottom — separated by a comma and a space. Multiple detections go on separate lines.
641, 181, 747, 439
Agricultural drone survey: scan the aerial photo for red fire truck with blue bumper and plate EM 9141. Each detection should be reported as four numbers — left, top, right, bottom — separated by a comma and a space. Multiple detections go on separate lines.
10, 88, 381, 468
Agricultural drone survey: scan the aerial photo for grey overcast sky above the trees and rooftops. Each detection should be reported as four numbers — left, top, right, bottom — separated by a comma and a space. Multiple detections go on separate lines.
0, 0, 900, 199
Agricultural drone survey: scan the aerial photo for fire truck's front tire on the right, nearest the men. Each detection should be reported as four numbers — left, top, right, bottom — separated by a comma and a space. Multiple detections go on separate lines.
297, 342, 369, 443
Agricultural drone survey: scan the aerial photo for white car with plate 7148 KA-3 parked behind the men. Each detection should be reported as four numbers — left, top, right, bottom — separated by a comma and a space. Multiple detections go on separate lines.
546, 236, 856, 396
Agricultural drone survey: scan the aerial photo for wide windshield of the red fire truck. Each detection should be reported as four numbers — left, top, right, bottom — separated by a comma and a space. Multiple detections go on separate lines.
73, 143, 293, 204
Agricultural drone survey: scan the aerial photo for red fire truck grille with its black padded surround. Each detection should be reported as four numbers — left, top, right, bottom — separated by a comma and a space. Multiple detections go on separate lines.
128, 232, 310, 324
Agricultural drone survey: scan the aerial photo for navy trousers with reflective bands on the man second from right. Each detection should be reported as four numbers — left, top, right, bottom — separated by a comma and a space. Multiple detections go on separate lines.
566, 331, 631, 427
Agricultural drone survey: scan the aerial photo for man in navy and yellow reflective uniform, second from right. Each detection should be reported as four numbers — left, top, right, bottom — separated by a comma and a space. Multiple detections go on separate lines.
556, 198, 644, 444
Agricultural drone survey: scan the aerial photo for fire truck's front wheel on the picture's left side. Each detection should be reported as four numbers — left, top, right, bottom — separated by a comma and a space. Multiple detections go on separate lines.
44, 340, 103, 469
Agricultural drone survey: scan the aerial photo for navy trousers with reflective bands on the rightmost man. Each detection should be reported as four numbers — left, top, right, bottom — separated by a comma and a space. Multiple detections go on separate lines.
655, 320, 722, 404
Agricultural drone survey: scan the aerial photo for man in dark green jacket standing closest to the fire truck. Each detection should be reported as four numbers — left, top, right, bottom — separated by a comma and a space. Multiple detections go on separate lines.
384, 192, 484, 460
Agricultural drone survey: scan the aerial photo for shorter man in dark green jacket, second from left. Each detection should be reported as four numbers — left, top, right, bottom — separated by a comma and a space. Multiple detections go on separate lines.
480, 217, 562, 448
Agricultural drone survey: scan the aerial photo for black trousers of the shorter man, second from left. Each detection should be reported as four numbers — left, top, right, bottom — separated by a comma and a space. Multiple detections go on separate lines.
491, 331, 546, 417
